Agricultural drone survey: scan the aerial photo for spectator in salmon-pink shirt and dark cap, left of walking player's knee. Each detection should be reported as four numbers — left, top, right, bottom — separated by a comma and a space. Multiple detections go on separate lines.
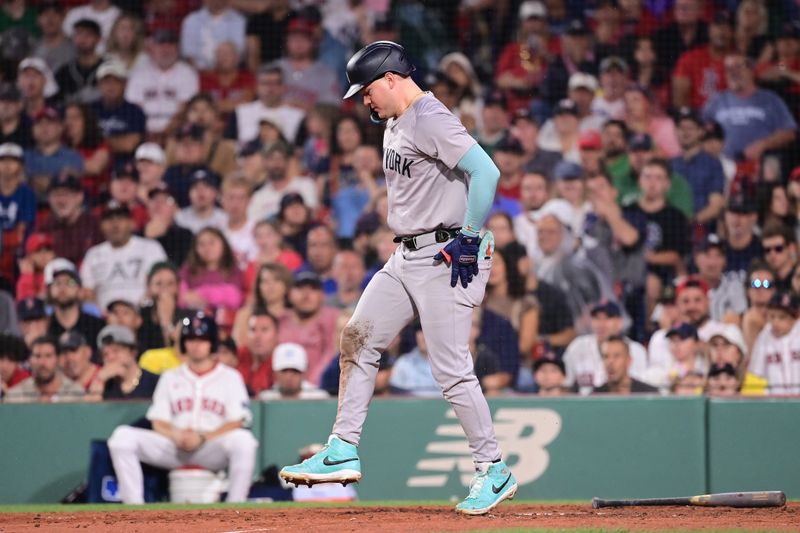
280, 272, 339, 385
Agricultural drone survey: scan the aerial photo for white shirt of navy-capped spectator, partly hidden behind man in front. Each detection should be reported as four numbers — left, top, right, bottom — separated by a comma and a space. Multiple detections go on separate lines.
564, 334, 647, 395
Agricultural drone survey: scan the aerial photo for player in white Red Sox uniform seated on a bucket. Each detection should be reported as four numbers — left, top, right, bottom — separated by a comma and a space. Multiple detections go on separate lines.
108, 313, 258, 503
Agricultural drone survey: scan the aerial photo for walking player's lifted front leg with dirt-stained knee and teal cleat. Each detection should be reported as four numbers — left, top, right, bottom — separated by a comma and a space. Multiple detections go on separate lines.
280, 251, 414, 485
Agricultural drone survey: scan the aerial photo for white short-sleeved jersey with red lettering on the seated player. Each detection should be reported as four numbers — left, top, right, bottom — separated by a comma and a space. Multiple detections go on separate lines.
147, 363, 253, 433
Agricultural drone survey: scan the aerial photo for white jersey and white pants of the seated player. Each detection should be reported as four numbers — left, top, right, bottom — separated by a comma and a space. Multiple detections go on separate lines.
108, 364, 258, 503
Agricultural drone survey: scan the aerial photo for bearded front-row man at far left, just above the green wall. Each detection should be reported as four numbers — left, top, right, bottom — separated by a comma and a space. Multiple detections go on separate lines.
4, 336, 84, 403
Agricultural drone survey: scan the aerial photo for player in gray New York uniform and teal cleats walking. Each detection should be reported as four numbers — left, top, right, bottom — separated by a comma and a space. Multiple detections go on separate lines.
280, 41, 517, 515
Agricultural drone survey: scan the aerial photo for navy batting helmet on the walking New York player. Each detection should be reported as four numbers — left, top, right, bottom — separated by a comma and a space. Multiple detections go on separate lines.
344, 41, 416, 100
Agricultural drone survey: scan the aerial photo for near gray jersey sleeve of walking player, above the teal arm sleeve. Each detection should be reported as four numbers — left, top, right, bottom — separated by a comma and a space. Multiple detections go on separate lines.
414, 104, 476, 169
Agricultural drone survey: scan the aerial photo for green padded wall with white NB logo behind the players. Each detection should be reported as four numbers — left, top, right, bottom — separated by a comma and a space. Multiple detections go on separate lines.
0, 397, 800, 503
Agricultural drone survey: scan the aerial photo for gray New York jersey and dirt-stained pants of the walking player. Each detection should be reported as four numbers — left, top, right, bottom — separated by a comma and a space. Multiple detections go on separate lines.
333, 93, 500, 462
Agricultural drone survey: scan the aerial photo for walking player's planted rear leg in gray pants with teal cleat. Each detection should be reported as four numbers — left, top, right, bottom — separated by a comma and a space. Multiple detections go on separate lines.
406, 244, 517, 514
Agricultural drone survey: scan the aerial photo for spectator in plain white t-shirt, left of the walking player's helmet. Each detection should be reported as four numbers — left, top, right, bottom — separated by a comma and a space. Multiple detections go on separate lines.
234, 63, 306, 144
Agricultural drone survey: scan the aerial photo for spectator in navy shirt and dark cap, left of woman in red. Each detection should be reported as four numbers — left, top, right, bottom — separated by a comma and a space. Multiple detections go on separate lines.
25, 107, 84, 196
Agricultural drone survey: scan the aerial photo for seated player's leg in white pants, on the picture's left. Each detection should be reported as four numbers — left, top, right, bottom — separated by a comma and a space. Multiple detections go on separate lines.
108, 426, 181, 504
